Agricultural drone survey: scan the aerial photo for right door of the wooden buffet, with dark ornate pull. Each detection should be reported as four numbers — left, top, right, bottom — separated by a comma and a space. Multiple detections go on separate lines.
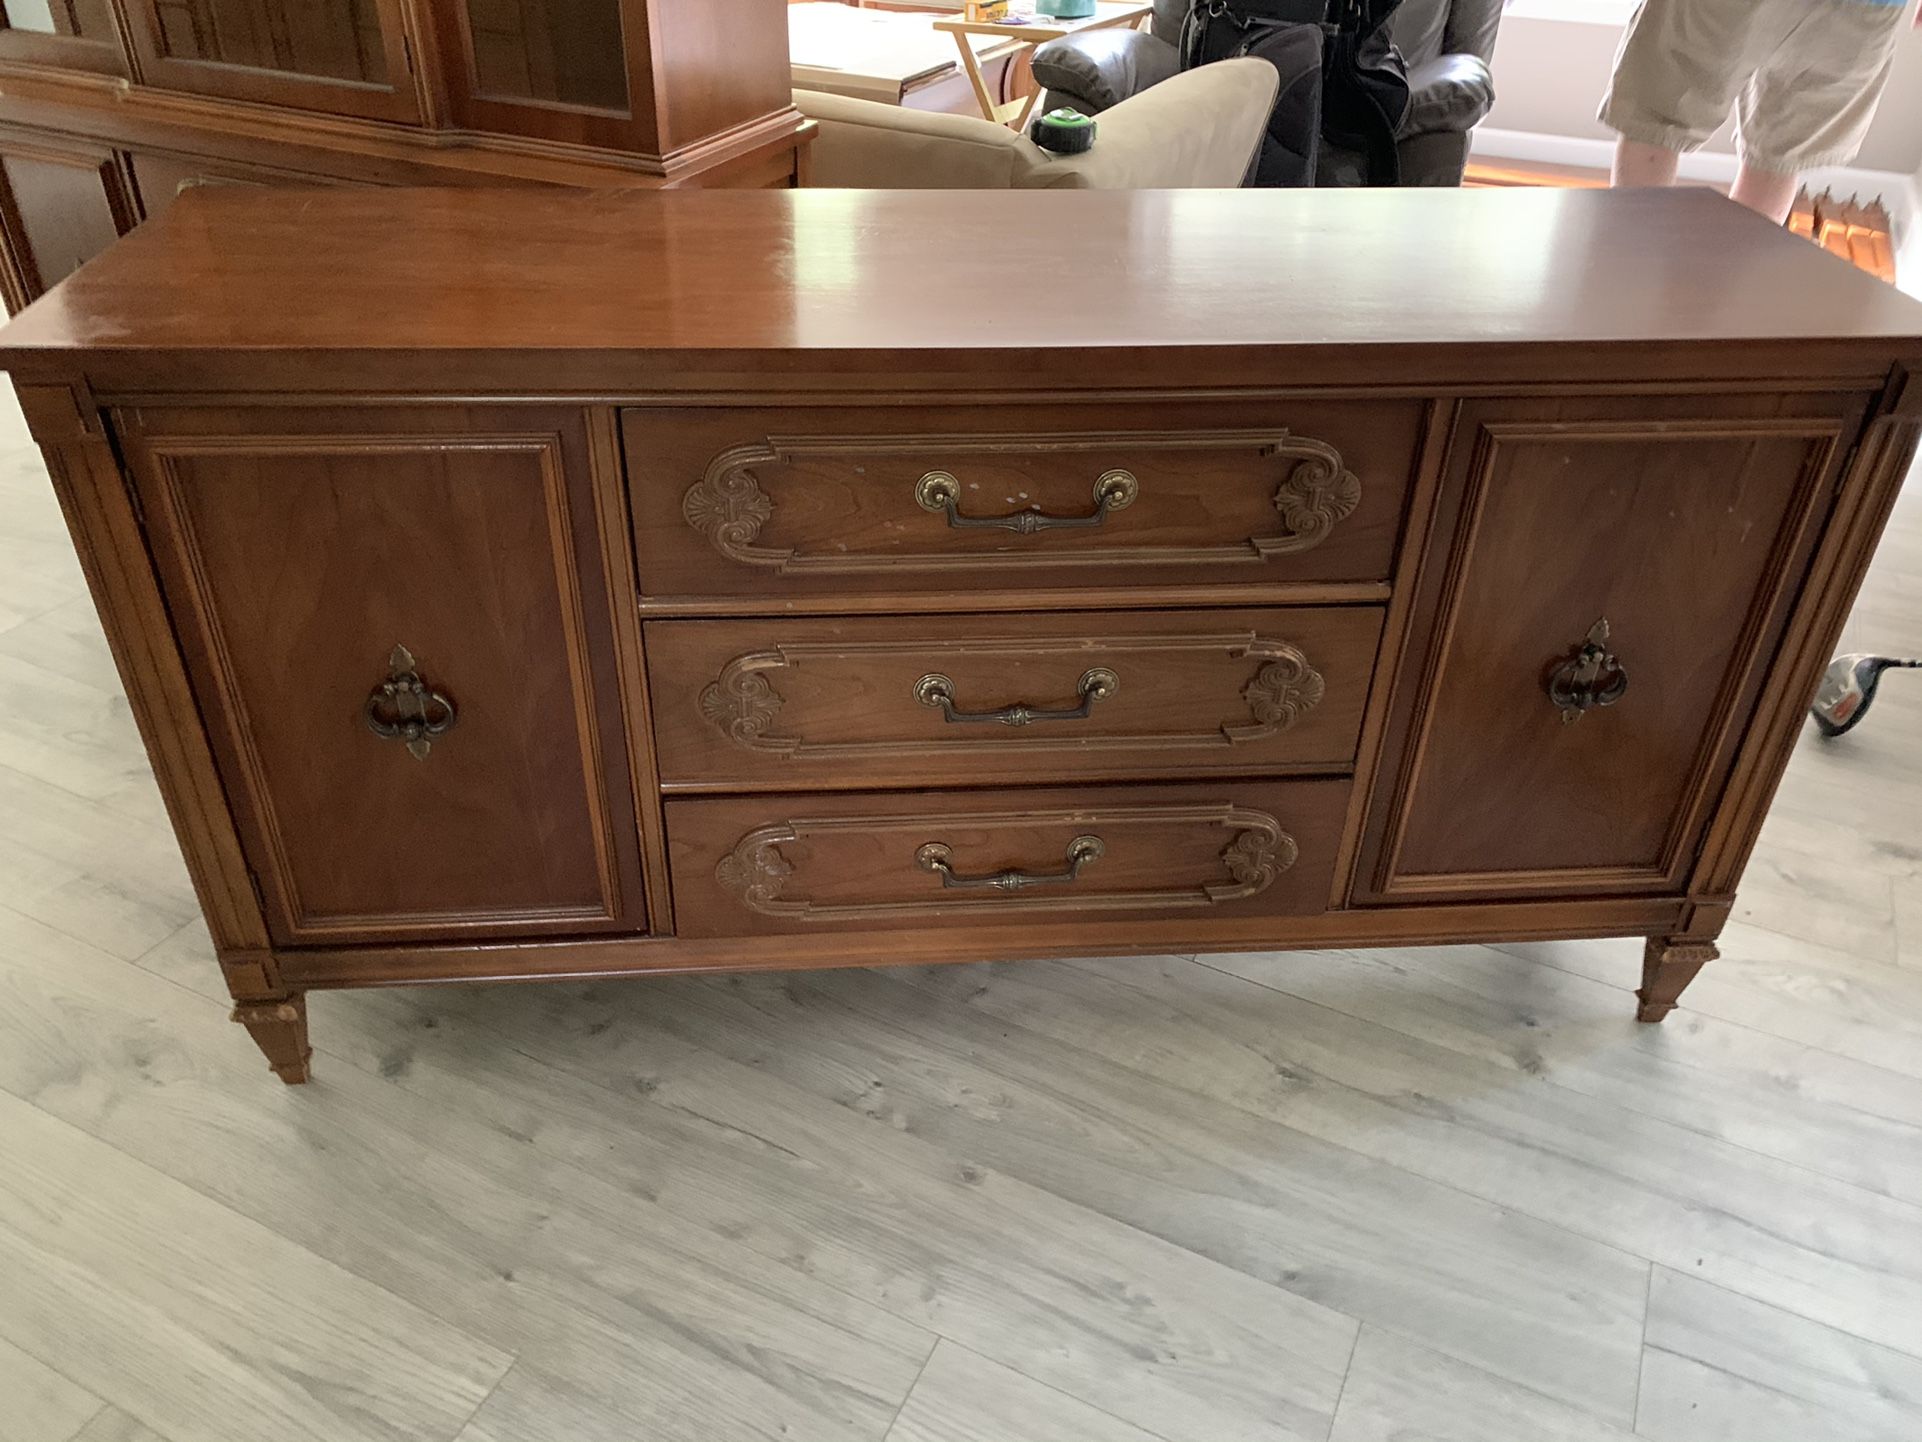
1357, 396, 1860, 900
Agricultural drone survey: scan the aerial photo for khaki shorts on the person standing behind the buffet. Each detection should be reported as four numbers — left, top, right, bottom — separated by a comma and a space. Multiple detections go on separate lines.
1601, 0, 1905, 175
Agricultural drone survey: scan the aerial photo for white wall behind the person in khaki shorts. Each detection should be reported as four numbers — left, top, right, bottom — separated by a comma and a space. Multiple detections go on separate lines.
1486, 0, 1922, 175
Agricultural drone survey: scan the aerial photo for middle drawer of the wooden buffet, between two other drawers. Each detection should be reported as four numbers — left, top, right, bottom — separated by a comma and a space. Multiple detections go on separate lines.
646, 606, 1382, 790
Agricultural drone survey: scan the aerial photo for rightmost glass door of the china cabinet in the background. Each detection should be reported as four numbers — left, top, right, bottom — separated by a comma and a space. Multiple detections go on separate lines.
436, 0, 646, 148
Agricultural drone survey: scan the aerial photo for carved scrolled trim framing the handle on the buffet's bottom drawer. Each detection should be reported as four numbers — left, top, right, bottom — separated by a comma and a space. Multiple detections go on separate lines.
715, 802, 1299, 921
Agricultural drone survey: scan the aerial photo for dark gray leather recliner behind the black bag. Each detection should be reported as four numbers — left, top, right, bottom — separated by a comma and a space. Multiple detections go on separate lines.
1034, 0, 1501, 185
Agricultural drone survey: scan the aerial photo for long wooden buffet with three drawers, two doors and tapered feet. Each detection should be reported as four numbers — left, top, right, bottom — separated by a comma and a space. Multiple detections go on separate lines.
0, 190, 1922, 1081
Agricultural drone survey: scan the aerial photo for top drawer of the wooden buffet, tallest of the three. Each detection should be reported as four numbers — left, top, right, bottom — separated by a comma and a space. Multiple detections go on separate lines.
621, 400, 1422, 602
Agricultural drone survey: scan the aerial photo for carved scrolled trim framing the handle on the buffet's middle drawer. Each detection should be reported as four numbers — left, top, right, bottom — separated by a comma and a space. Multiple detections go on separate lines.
698, 631, 1328, 759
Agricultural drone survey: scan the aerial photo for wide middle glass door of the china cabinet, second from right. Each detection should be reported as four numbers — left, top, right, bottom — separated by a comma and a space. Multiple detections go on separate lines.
121, 0, 421, 121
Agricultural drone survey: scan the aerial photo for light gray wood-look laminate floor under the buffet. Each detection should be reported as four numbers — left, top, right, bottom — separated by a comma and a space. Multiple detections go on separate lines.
0, 402, 1922, 1442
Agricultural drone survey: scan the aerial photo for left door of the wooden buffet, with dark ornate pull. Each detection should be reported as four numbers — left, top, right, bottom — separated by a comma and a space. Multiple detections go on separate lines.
121, 411, 640, 944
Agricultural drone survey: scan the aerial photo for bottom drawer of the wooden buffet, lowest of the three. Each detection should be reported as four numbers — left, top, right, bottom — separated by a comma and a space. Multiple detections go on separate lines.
667, 781, 1349, 936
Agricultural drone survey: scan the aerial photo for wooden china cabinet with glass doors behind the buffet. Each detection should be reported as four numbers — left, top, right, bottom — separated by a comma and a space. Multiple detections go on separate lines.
0, 0, 807, 310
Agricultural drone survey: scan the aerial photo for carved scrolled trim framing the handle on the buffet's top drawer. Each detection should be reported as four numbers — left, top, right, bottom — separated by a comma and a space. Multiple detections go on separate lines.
680, 429, 1361, 575
